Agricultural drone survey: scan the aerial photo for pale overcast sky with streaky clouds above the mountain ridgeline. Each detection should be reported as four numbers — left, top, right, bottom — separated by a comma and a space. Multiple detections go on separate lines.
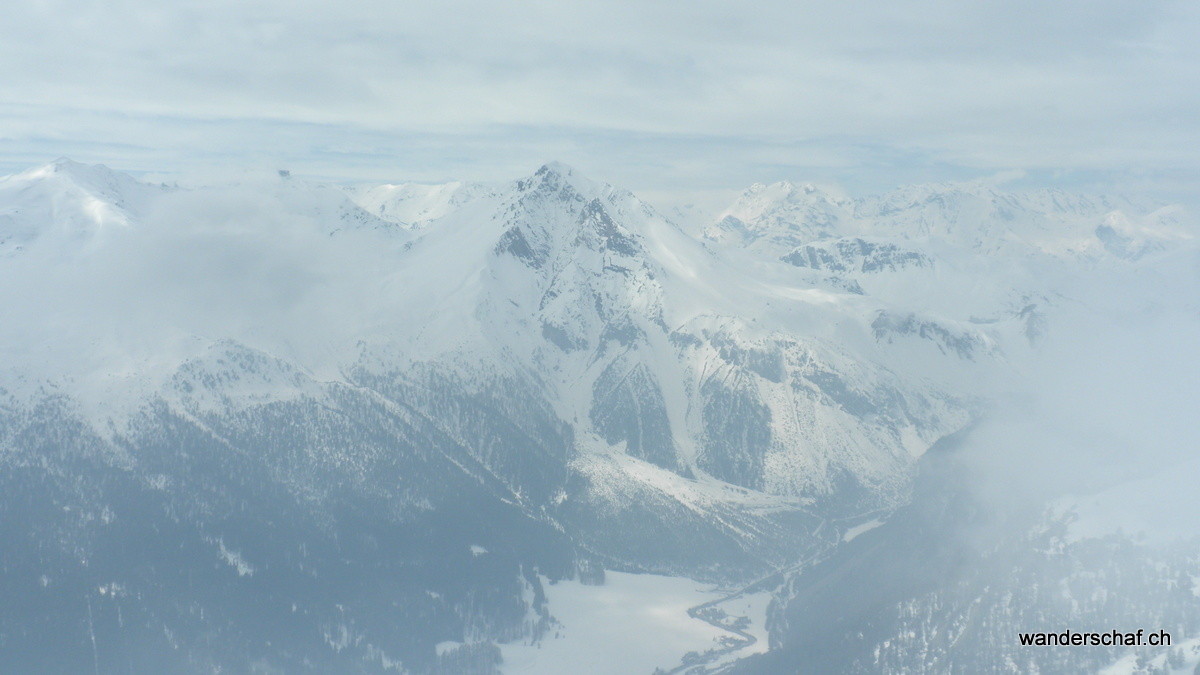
0, 0, 1200, 195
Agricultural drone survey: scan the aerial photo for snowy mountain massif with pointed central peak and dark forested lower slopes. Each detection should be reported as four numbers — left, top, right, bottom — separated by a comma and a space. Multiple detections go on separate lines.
0, 161, 1190, 671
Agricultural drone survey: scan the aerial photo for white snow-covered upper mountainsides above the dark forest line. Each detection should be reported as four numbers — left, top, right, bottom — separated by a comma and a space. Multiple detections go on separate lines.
0, 154, 1189, 509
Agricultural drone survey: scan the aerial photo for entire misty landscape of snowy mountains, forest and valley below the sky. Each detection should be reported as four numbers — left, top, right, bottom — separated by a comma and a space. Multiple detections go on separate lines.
0, 160, 1200, 673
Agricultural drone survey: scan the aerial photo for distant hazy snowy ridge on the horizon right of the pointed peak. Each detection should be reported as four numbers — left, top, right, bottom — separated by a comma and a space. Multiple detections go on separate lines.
703, 177, 1189, 257
